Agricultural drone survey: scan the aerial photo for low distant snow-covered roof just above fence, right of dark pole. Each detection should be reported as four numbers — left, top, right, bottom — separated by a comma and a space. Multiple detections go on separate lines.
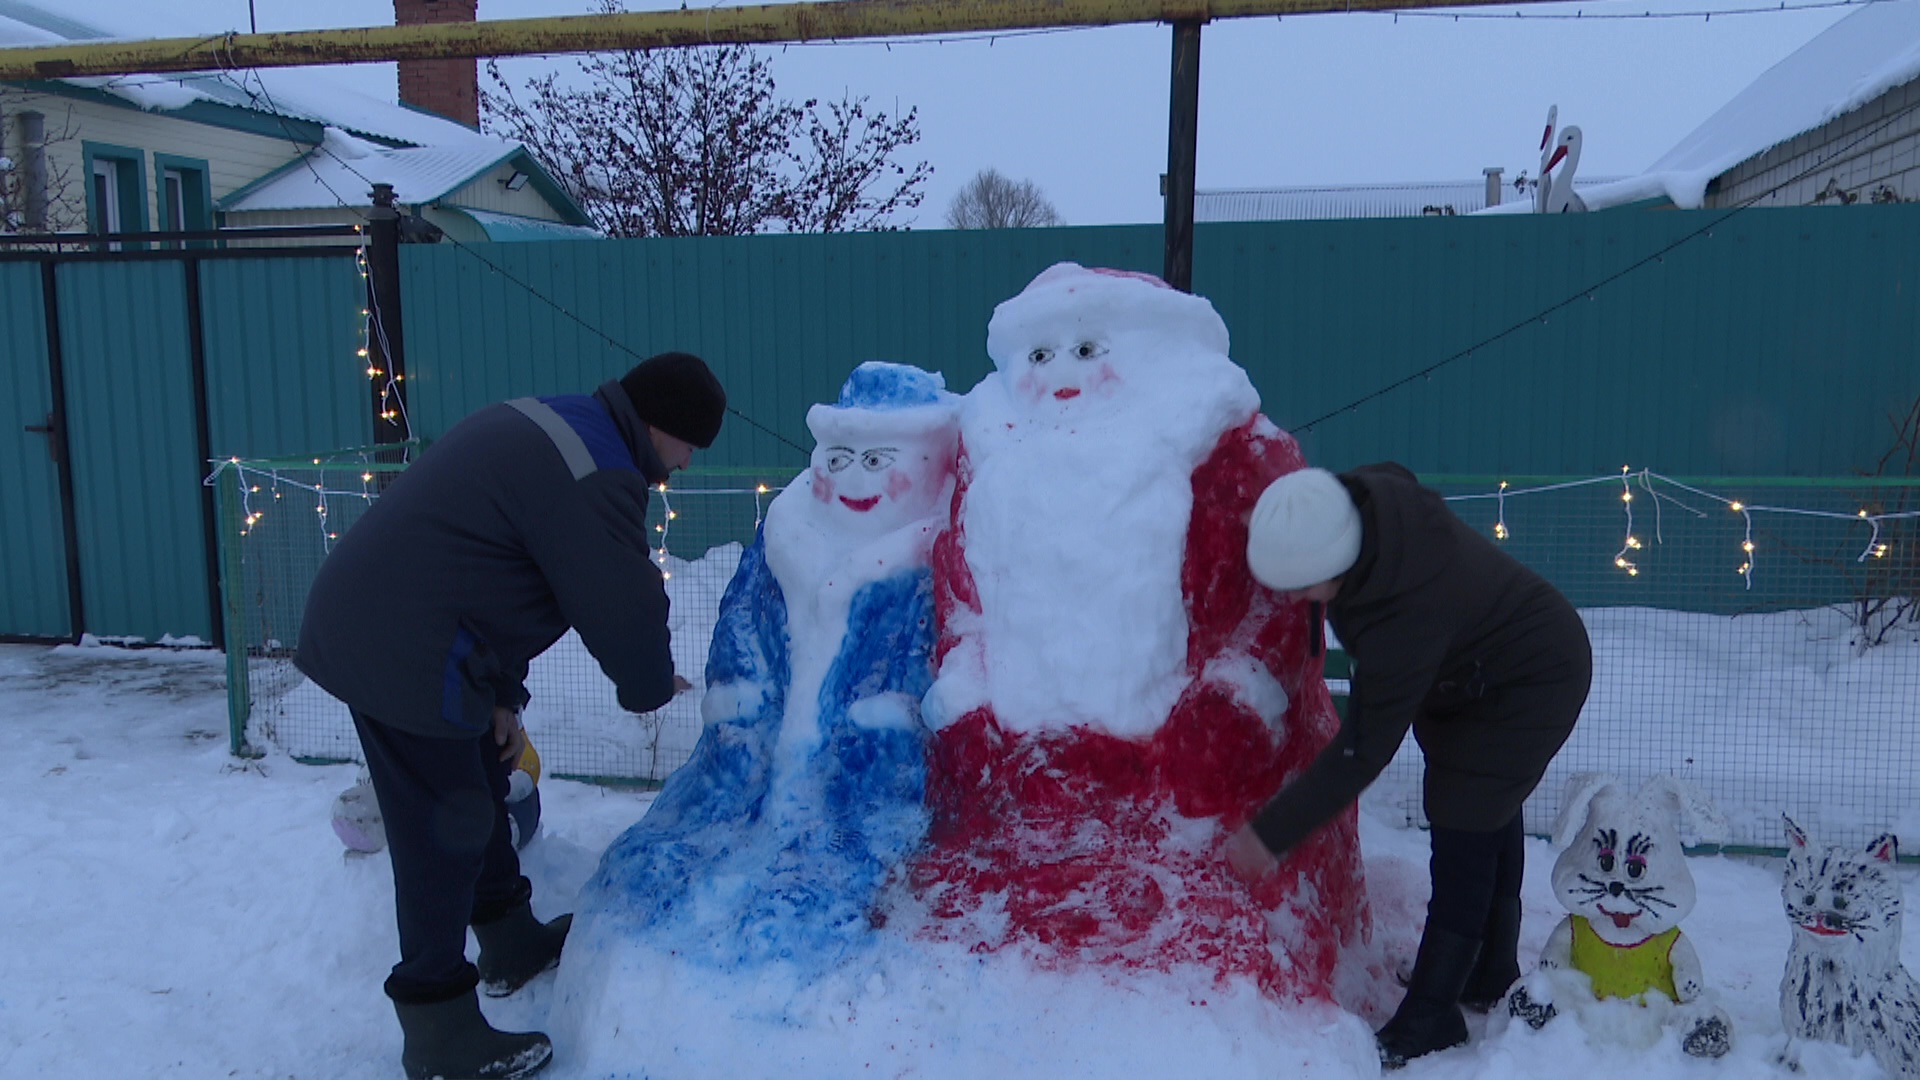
1194, 177, 1607, 221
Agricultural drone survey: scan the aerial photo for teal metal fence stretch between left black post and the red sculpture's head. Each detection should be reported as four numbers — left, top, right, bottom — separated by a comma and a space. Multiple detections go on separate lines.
401, 227, 1162, 467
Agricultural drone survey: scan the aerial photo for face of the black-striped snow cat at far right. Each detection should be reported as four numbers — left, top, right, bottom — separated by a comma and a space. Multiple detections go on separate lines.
1780, 819, 1901, 949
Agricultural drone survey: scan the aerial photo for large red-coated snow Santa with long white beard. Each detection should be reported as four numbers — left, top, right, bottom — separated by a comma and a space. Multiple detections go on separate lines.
910, 263, 1369, 999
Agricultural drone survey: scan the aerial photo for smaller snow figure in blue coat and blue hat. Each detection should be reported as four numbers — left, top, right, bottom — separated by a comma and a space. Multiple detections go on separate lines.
563, 363, 958, 976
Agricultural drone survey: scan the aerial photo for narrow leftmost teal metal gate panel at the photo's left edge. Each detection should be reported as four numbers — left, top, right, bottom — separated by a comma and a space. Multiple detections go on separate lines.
0, 263, 71, 638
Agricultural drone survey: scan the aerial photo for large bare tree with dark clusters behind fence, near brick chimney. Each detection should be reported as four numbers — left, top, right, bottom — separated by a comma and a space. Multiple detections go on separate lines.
480, 0, 933, 236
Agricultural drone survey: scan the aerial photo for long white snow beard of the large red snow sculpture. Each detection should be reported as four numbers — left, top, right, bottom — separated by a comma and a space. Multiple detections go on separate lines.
944, 350, 1260, 738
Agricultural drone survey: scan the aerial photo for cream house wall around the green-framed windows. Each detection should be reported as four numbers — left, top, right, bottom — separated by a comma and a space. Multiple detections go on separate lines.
0, 90, 301, 229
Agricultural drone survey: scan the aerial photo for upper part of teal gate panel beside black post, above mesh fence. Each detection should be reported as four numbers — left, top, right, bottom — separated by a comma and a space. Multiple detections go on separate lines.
200, 256, 372, 457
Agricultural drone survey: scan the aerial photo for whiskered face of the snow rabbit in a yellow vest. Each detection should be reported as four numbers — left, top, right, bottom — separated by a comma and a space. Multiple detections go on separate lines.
1553, 788, 1693, 945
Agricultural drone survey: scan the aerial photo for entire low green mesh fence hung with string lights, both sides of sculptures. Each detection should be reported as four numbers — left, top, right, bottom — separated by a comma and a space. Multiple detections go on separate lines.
215, 450, 1920, 847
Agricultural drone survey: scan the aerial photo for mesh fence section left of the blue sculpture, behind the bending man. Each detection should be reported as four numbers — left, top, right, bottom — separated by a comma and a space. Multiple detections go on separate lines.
213, 448, 793, 782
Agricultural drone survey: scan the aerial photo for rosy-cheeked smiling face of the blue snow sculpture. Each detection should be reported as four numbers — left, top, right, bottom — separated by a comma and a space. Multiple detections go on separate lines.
812, 438, 952, 536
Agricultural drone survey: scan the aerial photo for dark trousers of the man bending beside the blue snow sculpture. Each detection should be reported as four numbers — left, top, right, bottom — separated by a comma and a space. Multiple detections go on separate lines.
353, 711, 534, 1005
